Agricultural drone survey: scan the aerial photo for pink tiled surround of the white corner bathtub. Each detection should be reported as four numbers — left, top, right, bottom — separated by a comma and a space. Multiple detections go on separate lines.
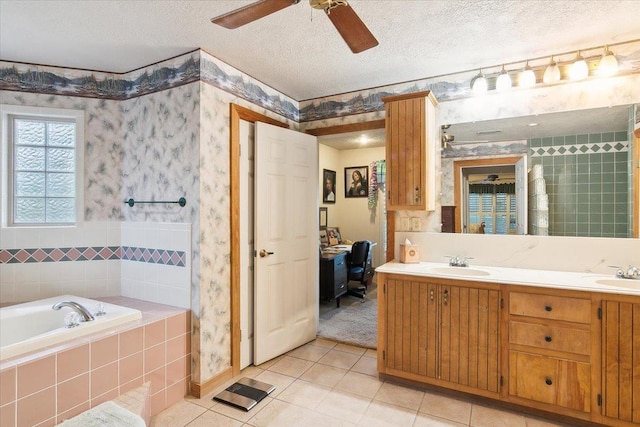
0, 297, 191, 427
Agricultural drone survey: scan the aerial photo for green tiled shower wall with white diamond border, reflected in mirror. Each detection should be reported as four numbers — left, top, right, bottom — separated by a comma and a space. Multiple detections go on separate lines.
527, 130, 630, 237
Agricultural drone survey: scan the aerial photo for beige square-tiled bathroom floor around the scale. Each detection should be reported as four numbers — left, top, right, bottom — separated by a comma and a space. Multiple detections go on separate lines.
151, 339, 562, 427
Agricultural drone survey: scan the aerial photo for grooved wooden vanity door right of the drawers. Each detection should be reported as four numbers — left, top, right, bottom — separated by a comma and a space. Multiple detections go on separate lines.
602, 301, 640, 423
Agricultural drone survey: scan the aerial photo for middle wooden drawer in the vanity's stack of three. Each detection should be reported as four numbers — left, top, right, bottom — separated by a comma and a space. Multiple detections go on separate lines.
509, 320, 591, 356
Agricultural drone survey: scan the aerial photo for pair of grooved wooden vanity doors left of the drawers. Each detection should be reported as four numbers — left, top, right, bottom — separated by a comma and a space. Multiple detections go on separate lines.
378, 273, 500, 397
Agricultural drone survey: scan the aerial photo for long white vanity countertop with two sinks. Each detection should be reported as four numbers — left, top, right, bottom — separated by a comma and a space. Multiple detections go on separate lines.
376, 262, 640, 296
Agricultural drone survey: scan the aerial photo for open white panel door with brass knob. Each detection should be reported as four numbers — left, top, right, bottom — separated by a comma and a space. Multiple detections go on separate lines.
253, 122, 319, 365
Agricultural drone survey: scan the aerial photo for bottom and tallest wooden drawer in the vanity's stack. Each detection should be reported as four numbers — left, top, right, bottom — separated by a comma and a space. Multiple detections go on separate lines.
509, 351, 591, 412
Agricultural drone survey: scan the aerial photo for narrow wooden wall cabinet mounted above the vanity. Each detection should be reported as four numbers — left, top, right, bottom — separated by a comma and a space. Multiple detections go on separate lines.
382, 91, 438, 211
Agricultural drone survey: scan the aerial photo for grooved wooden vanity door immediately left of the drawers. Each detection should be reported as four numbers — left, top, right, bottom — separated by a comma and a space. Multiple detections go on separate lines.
439, 285, 500, 393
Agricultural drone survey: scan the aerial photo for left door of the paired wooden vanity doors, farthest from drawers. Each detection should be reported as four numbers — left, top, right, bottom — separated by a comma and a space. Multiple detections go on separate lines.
383, 278, 437, 380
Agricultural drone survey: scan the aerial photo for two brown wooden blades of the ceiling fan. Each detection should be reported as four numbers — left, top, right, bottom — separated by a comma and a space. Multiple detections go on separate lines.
211, 0, 378, 53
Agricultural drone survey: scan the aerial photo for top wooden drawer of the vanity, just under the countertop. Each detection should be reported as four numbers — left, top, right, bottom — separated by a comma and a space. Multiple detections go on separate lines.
509, 292, 591, 323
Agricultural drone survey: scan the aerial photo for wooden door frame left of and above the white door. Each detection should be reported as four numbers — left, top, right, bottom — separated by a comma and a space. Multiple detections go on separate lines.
229, 103, 289, 378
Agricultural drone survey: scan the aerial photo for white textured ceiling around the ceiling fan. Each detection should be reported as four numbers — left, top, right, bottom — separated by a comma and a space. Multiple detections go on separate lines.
0, 0, 640, 101
